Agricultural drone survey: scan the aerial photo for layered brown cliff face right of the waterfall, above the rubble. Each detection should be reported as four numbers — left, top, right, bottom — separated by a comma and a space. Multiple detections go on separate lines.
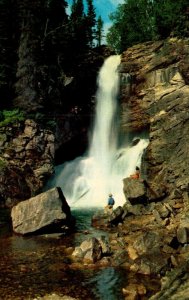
120, 39, 189, 199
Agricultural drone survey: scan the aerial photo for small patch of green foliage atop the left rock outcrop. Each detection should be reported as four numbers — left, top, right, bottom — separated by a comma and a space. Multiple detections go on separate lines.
0, 109, 25, 127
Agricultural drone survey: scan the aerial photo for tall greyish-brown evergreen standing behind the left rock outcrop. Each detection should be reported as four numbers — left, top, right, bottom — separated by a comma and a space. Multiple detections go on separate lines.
14, 0, 44, 111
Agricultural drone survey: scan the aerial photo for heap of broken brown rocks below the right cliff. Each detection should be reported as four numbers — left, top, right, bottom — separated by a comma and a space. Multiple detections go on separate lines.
92, 186, 189, 276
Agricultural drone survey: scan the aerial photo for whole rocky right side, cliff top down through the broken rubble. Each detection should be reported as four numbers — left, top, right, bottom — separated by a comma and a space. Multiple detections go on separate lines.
108, 38, 189, 290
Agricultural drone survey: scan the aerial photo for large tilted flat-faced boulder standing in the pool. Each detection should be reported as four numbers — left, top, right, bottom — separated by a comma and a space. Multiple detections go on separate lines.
11, 187, 72, 235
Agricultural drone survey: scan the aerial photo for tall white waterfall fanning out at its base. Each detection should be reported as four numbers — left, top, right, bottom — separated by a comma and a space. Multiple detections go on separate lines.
48, 55, 148, 207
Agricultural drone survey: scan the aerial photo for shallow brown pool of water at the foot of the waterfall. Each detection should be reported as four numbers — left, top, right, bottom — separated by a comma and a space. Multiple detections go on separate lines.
0, 210, 159, 300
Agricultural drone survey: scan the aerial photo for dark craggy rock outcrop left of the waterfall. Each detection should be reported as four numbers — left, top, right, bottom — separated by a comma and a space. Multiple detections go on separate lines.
0, 120, 55, 206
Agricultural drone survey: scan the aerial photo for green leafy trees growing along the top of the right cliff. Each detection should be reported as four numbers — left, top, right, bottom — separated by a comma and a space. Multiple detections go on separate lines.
107, 0, 189, 53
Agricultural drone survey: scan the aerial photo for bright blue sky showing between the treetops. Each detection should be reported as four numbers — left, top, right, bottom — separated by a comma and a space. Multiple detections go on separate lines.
67, 0, 124, 41
